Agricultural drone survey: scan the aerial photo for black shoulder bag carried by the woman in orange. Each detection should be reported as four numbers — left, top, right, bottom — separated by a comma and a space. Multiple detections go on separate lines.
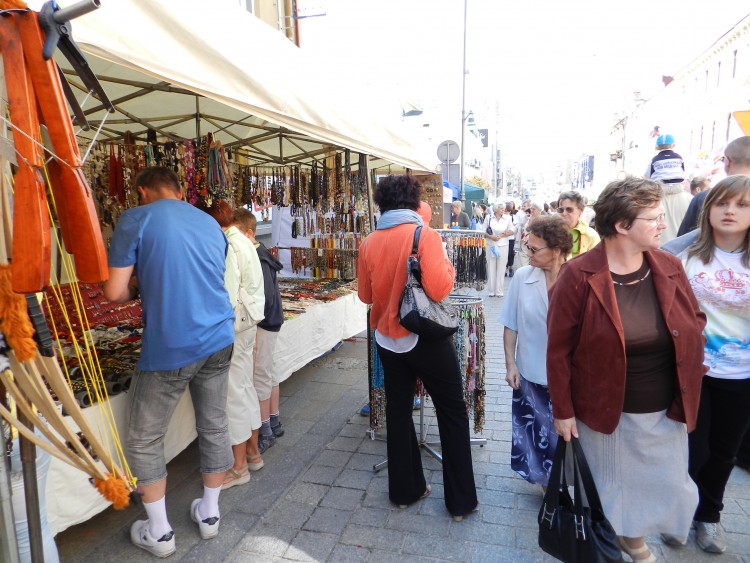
398, 227, 459, 339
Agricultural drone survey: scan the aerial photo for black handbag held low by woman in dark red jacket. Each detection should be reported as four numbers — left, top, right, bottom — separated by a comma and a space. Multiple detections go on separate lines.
537, 437, 622, 563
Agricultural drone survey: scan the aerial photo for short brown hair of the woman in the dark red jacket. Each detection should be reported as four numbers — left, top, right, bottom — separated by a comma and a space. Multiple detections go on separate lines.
594, 176, 664, 239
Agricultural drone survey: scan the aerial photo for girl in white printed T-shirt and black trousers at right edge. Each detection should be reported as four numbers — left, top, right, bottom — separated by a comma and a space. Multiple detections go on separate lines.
664, 174, 750, 553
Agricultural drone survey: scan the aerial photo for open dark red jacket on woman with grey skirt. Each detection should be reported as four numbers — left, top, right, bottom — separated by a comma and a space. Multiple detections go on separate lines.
547, 245, 707, 434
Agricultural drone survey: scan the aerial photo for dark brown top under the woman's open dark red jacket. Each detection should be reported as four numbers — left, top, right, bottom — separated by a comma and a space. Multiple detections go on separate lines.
610, 259, 677, 413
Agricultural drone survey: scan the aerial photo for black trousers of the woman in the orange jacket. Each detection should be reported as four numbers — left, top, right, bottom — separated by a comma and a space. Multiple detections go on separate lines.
378, 337, 477, 516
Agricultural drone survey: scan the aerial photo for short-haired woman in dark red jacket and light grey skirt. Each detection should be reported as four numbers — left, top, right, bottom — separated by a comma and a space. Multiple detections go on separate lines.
547, 177, 706, 562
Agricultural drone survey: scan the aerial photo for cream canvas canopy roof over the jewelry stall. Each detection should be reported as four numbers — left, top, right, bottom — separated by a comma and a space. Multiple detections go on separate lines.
61, 0, 432, 170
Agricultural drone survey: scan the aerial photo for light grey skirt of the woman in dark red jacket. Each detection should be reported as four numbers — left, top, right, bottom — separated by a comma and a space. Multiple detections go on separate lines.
576, 411, 698, 538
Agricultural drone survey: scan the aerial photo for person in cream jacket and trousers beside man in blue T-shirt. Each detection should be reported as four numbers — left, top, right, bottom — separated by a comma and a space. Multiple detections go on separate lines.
206, 200, 266, 489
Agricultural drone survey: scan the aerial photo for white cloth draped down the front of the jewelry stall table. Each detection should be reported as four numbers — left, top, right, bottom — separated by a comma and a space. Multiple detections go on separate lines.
47, 293, 367, 534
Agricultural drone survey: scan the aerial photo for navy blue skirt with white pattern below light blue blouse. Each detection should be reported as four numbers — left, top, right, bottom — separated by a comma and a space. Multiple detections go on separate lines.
510, 376, 557, 487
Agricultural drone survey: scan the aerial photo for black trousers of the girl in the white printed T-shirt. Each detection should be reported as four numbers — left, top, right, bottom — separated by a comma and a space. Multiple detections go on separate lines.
689, 377, 750, 522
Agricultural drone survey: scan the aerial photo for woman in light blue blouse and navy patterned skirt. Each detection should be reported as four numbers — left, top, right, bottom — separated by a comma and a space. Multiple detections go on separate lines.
500, 216, 573, 487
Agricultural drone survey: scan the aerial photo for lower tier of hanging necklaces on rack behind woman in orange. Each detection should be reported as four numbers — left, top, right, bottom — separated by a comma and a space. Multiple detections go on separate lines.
368, 295, 487, 434
